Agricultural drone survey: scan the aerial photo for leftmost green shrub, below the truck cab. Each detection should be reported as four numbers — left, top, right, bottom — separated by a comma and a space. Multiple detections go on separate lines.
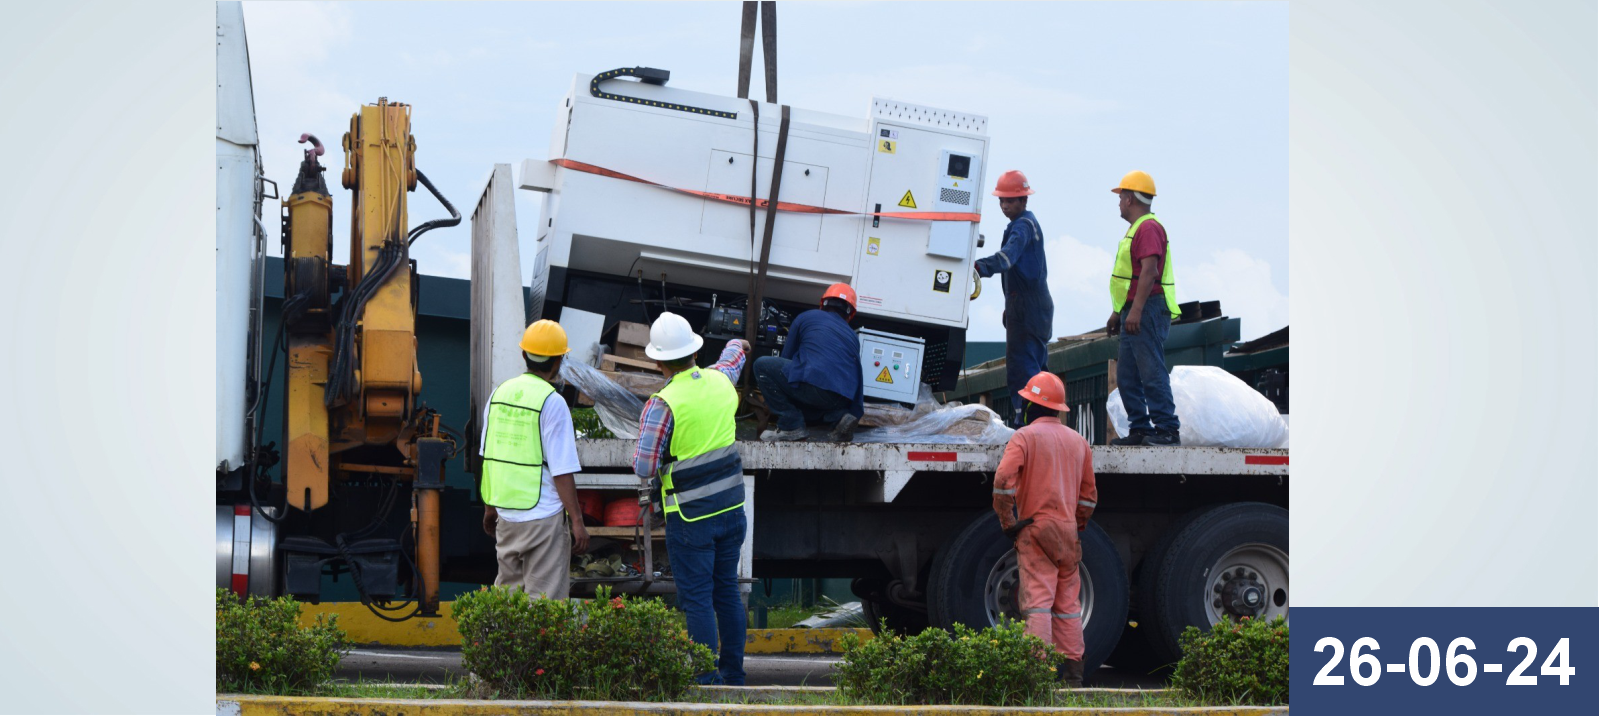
216, 588, 345, 694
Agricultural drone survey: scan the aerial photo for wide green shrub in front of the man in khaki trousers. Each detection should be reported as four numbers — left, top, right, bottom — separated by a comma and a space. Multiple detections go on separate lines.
454, 587, 715, 702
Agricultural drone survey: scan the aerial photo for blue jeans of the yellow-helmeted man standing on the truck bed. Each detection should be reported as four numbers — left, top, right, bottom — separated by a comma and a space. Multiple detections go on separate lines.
1116, 296, 1182, 433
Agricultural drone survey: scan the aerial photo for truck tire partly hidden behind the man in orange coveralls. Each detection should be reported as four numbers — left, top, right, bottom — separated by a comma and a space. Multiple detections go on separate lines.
927, 511, 1127, 674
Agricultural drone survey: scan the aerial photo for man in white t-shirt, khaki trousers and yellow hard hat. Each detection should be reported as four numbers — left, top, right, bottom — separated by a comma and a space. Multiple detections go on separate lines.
480, 320, 588, 599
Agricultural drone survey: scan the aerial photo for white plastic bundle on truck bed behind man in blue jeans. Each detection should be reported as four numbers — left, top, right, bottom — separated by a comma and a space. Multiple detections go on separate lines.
1105, 366, 1289, 448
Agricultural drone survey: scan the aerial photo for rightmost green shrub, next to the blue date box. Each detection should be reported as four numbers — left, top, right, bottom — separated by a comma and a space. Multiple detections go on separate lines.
1172, 617, 1289, 705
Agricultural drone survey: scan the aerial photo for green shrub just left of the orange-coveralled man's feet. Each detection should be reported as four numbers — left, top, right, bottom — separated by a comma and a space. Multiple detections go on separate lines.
833, 620, 1065, 706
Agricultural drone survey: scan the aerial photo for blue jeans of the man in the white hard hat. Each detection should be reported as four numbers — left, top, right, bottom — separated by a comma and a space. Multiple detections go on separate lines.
667, 507, 745, 686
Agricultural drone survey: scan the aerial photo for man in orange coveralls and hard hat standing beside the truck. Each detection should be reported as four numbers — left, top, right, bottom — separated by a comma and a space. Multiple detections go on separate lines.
995, 372, 1099, 687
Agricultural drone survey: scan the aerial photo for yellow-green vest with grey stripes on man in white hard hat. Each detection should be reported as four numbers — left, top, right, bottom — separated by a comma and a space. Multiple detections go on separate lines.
656, 368, 744, 523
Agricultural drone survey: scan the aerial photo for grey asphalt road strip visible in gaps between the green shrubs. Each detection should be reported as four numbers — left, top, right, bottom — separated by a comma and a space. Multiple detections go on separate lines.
337, 647, 1166, 689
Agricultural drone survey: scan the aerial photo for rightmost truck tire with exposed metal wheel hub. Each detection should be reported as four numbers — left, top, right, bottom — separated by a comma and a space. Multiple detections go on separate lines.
1138, 502, 1289, 663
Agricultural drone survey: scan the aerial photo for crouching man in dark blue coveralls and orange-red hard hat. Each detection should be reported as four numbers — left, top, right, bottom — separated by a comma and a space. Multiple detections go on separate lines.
755, 283, 865, 443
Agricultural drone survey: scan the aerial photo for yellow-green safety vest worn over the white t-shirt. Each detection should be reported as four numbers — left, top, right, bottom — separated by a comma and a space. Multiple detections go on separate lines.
481, 372, 555, 510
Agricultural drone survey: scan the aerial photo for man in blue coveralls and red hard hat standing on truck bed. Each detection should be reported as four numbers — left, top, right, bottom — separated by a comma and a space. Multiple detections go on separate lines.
975, 169, 1055, 428
